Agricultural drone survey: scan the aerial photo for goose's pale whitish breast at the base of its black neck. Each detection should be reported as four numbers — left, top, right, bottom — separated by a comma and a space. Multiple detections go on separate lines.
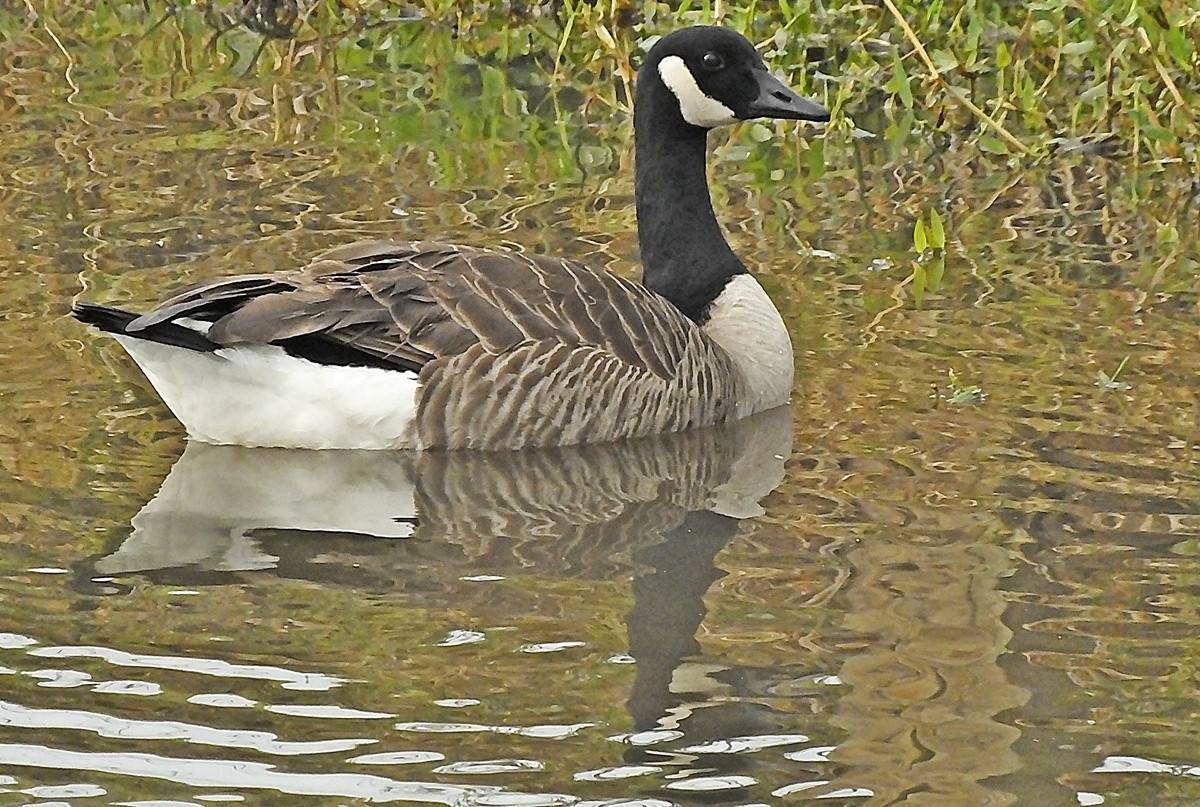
702, 275, 796, 418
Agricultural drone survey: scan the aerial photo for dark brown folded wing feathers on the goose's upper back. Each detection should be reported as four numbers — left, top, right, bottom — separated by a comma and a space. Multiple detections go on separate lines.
130, 241, 682, 376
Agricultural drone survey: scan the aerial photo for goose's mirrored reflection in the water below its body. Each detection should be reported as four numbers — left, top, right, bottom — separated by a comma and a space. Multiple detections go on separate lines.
83, 407, 792, 739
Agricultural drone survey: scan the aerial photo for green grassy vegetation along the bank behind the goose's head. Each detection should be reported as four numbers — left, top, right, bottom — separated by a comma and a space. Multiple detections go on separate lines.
9, 0, 1200, 177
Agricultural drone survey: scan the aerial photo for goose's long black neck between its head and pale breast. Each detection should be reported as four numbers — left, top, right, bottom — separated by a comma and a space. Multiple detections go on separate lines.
634, 76, 745, 322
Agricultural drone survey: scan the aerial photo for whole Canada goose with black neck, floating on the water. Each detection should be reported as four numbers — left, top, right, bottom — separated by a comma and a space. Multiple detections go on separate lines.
74, 26, 829, 449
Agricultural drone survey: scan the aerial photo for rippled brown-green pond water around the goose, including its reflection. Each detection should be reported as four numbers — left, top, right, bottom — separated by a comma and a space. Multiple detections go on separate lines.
0, 4, 1200, 807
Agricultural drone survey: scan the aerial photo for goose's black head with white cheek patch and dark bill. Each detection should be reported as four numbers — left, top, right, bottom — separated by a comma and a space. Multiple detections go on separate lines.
638, 25, 829, 128
